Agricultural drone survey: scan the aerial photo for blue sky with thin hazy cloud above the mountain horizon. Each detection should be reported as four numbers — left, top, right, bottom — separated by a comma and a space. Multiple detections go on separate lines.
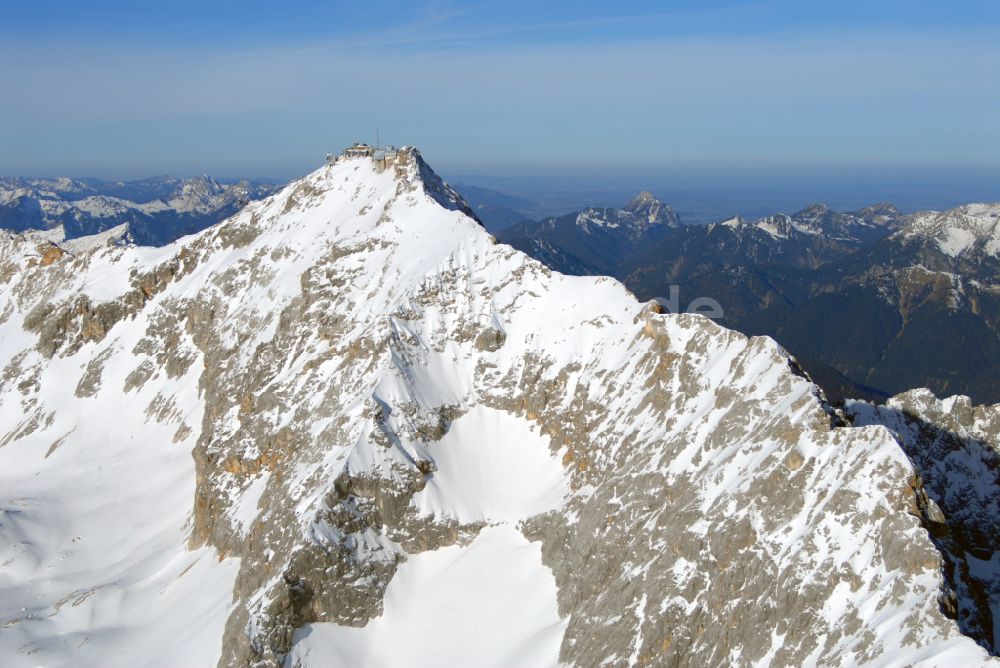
0, 0, 1000, 180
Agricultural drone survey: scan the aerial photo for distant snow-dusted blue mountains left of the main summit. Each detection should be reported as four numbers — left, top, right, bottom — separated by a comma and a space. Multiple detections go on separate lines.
0, 175, 277, 246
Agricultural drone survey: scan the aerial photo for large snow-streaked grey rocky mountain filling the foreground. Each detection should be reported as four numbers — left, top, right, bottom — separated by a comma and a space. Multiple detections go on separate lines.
0, 149, 992, 666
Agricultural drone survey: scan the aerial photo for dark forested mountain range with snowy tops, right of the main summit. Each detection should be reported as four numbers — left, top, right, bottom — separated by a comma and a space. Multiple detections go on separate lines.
498, 194, 1000, 402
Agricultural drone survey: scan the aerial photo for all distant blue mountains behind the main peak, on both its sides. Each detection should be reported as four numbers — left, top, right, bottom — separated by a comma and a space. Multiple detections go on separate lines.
0, 176, 1000, 402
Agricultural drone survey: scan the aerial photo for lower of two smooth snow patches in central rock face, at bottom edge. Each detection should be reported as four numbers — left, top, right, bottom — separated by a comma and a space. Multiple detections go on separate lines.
286, 526, 566, 668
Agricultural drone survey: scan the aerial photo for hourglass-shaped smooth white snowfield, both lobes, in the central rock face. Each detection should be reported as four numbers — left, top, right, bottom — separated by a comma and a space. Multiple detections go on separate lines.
286, 407, 569, 668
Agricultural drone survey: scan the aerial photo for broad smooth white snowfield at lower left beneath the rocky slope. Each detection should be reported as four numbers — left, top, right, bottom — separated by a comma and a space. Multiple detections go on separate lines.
0, 342, 238, 668
